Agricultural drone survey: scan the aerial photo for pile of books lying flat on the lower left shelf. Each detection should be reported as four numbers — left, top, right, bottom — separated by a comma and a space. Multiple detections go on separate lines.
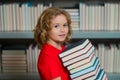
1, 45, 27, 72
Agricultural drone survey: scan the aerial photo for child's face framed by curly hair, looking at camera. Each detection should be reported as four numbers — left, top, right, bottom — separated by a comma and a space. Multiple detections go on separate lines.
48, 14, 68, 42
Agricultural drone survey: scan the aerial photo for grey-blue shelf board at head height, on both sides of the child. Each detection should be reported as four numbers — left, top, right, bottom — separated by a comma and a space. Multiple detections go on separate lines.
0, 30, 120, 39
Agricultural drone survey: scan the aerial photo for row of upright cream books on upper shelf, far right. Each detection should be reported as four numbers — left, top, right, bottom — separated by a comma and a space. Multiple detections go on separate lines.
79, 2, 120, 31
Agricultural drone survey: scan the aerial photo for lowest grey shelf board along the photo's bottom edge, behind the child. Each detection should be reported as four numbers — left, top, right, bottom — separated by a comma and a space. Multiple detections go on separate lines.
0, 73, 120, 80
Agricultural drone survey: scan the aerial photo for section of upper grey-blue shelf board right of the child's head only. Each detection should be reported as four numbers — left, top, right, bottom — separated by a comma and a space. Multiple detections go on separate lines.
72, 31, 120, 39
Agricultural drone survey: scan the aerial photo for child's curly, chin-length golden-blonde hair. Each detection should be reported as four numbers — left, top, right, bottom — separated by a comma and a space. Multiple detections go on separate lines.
34, 7, 72, 48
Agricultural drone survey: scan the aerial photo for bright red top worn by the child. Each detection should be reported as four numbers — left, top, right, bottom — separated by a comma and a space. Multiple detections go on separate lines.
38, 44, 70, 80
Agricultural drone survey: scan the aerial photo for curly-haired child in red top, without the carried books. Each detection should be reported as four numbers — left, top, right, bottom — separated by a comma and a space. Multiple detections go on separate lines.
34, 7, 71, 80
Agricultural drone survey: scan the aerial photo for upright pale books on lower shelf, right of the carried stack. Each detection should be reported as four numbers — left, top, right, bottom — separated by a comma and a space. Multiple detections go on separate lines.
97, 43, 120, 73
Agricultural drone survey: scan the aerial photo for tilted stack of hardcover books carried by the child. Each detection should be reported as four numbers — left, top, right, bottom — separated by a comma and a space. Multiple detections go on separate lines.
59, 39, 108, 80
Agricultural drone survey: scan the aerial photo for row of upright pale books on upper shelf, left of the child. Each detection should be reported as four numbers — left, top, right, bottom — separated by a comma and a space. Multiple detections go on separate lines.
0, 1, 52, 32
